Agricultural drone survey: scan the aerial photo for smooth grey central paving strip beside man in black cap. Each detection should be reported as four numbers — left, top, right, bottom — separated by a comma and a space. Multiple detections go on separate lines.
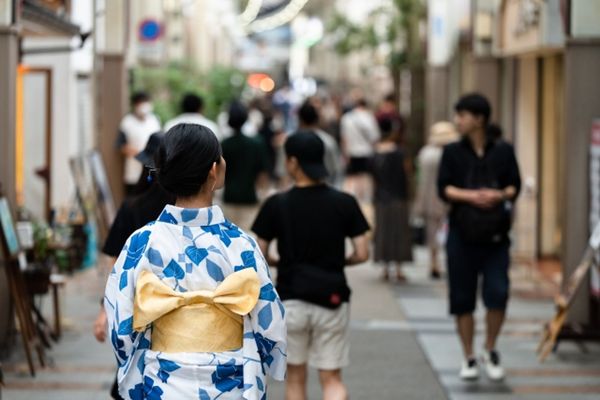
270, 266, 446, 400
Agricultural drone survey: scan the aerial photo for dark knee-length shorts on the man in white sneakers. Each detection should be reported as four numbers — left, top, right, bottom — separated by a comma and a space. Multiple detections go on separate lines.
446, 228, 510, 315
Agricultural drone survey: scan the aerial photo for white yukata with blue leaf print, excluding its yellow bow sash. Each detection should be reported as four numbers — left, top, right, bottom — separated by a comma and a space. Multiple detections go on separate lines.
104, 205, 286, 400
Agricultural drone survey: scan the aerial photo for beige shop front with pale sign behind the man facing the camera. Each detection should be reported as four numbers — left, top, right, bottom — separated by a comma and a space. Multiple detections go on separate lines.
494, 0, 565, 263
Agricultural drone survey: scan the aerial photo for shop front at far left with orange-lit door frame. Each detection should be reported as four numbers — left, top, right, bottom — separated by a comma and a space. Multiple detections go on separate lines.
0, 1, 80, 349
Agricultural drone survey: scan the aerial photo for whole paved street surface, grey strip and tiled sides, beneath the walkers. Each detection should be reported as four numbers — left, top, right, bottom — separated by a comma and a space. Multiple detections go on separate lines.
2, 247, 600, 400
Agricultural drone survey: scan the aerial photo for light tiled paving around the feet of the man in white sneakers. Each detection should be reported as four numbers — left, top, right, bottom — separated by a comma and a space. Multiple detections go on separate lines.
394, 248, 600, 400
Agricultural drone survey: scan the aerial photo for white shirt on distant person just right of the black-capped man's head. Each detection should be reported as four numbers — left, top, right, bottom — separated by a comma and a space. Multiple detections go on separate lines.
341, 108, 380, 157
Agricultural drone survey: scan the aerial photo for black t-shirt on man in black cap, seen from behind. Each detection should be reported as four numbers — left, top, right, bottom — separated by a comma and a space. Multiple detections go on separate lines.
252, 185, 369, 299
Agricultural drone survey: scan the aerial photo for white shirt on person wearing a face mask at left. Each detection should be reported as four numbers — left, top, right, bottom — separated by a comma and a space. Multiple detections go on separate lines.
119, 114, 160, 185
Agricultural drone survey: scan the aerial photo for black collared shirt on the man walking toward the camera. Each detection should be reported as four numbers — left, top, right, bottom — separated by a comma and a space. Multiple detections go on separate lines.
437, 137, 521, 227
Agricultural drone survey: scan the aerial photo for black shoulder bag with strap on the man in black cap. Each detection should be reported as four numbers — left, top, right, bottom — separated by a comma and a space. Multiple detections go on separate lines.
277, 192, 350, 309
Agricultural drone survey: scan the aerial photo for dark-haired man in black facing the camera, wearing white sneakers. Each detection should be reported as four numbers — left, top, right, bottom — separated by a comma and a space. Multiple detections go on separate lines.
438, 94, 521, 381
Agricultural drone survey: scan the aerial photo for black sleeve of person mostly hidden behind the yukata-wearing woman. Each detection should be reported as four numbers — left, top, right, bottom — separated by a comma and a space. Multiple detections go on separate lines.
102, 183, 175, 257
